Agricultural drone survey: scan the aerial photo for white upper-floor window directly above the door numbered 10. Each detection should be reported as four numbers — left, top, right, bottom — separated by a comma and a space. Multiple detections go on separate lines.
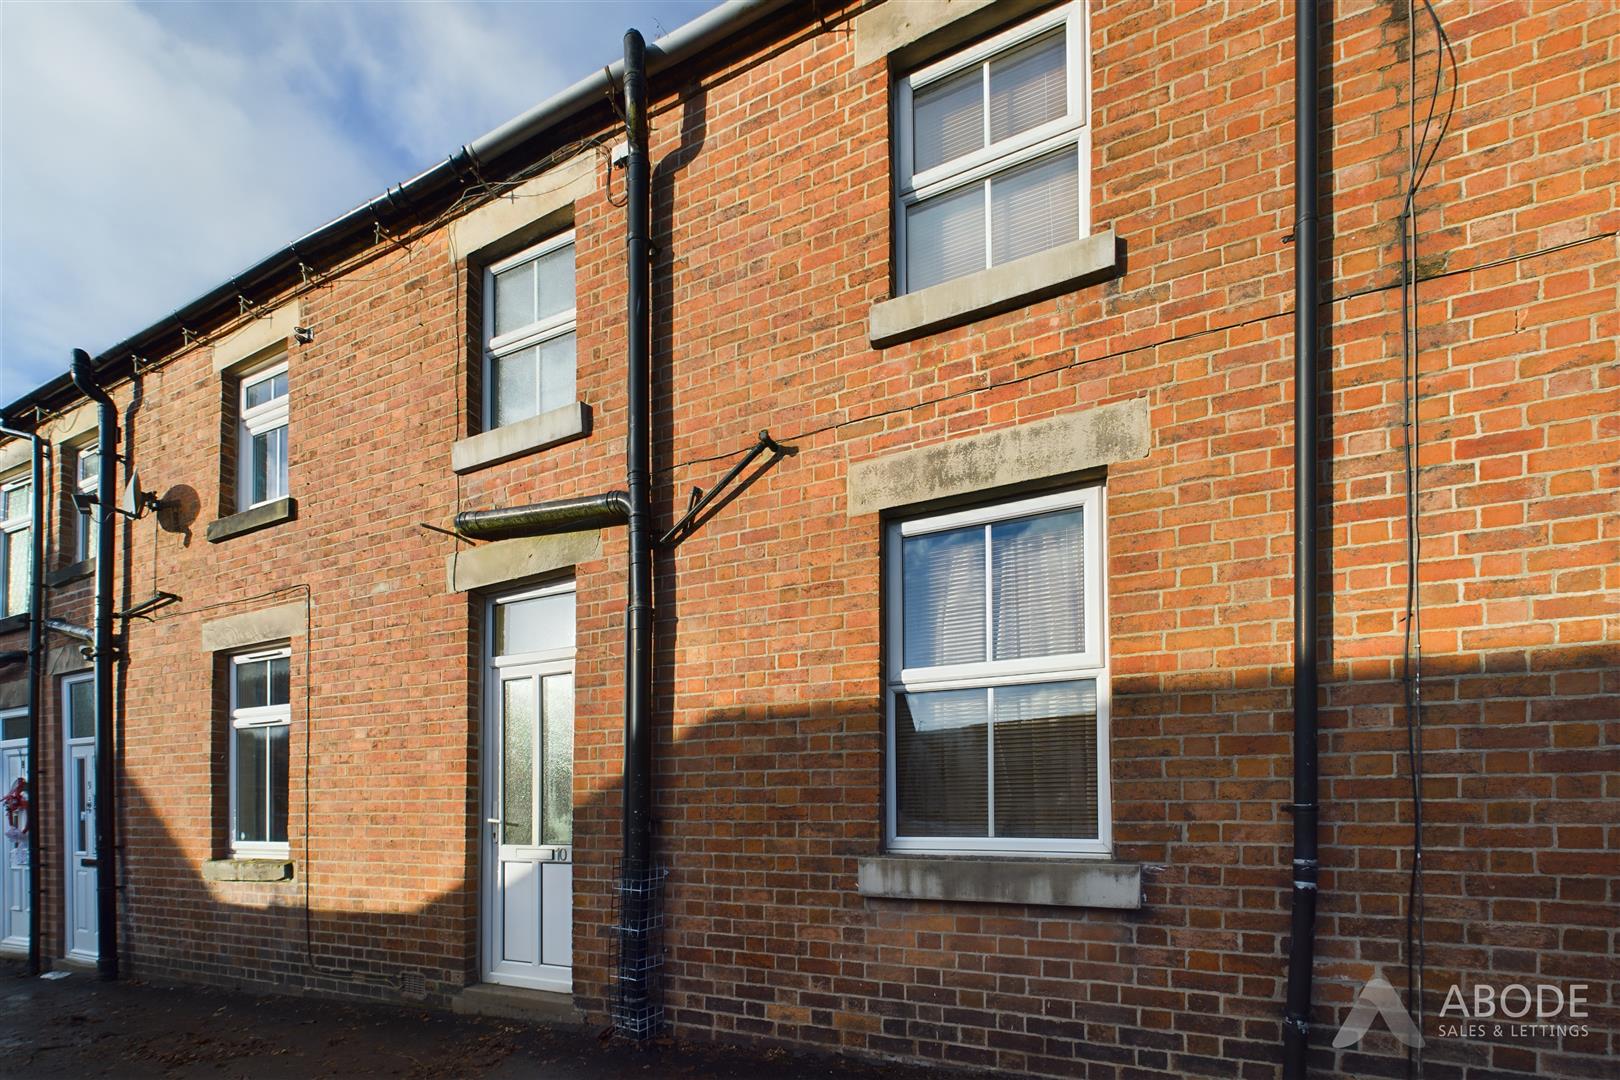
484, 232, 575, 431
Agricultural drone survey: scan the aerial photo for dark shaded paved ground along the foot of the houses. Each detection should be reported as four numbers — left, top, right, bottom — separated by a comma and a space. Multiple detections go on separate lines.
0, 960, 940, 1080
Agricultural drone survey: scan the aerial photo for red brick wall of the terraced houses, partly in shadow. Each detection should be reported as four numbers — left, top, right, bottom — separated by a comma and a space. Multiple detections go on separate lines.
3, 0, 1620, 1077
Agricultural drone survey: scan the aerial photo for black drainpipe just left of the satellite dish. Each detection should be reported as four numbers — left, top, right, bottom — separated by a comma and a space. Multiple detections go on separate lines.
73, 348, 118, 980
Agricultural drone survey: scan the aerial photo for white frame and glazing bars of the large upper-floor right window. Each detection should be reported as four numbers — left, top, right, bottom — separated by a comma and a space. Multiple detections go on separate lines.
894, 3, 1092, 295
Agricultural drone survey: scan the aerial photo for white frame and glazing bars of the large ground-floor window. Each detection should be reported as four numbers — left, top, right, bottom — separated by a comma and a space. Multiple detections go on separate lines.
883, 484, 1113, 857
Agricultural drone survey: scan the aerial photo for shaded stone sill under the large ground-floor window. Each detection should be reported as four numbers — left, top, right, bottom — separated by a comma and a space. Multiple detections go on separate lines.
857, 855, 1142, 912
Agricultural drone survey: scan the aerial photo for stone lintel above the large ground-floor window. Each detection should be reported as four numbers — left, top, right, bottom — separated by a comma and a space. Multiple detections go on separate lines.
844, 398, 1153, 517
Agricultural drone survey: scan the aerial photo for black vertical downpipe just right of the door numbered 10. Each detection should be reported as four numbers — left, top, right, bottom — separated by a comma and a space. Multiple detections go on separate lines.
616, 29, 656, 1038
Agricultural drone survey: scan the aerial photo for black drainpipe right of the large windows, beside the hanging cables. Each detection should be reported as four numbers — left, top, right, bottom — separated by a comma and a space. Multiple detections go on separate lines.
1283, 0, 1317, 1080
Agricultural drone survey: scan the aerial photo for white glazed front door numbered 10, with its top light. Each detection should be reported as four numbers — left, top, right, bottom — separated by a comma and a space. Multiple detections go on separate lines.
481, 583, 573, 991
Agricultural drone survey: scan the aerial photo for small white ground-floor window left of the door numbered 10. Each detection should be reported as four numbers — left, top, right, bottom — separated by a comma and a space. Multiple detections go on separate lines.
230, 648, 292, 858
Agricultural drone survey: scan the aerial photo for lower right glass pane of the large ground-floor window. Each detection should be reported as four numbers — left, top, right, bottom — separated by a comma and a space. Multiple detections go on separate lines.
993, 678, 1097, 839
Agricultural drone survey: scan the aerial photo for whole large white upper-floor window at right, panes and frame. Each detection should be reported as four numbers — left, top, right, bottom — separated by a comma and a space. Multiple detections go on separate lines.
894, 3, 1092, 293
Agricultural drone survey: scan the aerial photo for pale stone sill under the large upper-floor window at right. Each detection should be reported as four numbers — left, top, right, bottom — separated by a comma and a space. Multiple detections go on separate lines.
867, 228, 1119, 348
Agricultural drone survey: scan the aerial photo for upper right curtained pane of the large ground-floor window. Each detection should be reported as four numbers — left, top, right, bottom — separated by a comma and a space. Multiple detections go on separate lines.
990, 510, 1085, 661
